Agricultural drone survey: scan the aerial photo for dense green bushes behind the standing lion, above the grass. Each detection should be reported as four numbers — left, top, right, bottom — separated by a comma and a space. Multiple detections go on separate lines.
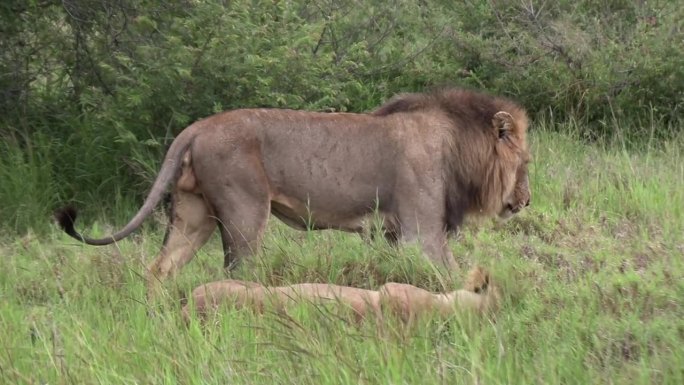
0, 0, 684, 232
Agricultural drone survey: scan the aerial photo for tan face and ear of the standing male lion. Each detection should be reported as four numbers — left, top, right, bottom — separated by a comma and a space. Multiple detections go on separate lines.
492, 111, 531, 219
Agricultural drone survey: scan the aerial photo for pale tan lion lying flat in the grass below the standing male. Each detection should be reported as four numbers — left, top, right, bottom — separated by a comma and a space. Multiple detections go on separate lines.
182, 267, 500, 323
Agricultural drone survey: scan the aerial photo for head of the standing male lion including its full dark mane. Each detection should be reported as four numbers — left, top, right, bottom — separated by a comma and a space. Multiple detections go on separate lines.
372, 89, 531, 228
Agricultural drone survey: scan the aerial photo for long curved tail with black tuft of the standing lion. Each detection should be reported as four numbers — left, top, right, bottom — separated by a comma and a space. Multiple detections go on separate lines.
54, 126, 197, 246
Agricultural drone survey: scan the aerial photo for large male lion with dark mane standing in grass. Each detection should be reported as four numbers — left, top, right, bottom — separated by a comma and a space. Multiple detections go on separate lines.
56, 89, 530, 296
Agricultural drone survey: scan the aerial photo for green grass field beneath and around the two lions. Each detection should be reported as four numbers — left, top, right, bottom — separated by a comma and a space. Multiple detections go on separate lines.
0, 124, 684, 384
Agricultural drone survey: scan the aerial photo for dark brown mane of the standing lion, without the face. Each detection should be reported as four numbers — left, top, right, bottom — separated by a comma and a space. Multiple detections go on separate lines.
371, 88, 528, 230
